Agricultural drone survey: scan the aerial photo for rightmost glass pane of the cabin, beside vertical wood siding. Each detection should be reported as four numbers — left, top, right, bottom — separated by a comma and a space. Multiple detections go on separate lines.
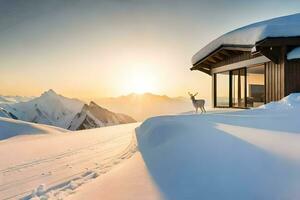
247, 65, 265, 107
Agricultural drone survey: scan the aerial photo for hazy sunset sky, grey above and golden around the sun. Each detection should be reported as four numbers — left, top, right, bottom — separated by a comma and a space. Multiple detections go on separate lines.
0, 0, 300, 99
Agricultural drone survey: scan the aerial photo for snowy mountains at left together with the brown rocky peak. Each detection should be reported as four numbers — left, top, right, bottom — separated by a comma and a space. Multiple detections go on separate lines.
0, 89, 135, 130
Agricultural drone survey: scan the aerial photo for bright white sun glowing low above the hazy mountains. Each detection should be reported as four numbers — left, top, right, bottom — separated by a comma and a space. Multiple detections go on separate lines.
124, 64, 157, 94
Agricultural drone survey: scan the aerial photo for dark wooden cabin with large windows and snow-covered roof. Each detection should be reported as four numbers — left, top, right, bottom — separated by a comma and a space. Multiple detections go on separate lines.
191, 13, 300, 108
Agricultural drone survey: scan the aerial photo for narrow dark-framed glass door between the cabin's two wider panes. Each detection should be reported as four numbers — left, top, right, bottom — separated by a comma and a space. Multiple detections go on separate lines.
231, 68, 246, 108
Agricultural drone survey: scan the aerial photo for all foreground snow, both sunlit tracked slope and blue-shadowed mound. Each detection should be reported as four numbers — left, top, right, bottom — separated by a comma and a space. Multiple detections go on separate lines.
0, 93, 300, 200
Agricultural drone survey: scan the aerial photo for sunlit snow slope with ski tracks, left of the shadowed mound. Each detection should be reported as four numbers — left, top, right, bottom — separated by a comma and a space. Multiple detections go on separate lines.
0, 121, 139, 199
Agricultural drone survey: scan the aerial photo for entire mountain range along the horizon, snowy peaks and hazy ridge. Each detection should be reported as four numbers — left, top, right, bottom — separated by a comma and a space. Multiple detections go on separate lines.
0, 89, 193, 130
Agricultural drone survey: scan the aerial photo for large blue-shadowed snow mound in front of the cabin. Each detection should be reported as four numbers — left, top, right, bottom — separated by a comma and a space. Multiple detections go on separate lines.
137, 94, 300, 200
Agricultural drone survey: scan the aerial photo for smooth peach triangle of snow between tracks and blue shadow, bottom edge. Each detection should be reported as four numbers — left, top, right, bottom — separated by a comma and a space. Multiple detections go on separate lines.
66, 153, 163, 200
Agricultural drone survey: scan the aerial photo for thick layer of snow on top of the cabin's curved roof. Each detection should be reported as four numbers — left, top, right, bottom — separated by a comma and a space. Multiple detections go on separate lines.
192, 13, 300, 64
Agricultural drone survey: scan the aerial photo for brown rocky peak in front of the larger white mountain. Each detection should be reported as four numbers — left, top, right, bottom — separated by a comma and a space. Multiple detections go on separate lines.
68, 101, 136, 130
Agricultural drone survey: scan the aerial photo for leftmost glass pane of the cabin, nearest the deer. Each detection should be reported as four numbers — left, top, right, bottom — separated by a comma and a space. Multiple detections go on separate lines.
215, 72, 229, 107
